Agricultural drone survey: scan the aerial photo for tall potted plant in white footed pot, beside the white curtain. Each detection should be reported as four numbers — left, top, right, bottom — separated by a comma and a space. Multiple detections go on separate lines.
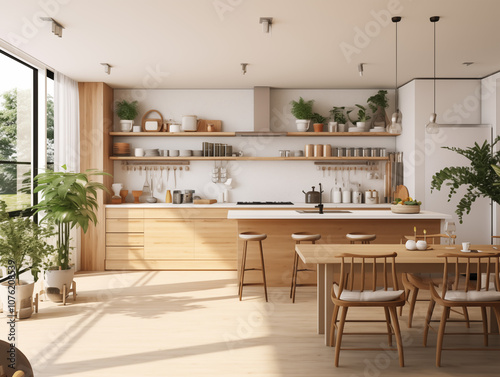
34, 165, 109, 301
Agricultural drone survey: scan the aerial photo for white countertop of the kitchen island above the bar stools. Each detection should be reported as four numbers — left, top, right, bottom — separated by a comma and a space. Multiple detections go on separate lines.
227, 210, 452, 220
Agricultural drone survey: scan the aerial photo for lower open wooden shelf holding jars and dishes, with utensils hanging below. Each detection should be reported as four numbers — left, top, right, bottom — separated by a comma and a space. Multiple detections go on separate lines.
109, 156, 389, 161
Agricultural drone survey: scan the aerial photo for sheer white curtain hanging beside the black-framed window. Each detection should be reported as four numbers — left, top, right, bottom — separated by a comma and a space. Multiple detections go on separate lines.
54, 72, 81, 271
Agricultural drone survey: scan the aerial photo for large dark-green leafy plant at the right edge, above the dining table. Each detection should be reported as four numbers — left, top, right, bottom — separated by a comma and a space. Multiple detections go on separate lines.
431, 136, 500, 223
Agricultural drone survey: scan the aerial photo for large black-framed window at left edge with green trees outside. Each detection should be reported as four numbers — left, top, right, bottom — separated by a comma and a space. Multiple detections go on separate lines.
0, 50, 38, 211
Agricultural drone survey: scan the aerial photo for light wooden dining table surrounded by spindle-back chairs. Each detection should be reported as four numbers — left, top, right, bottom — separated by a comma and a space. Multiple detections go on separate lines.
295, 244, 499, 346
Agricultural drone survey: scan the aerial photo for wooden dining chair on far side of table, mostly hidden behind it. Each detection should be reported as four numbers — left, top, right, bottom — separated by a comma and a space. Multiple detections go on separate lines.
399, 234, 470, 328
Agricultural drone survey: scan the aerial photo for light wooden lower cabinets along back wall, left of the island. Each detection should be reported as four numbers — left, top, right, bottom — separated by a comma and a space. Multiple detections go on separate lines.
106, 208, 238, 270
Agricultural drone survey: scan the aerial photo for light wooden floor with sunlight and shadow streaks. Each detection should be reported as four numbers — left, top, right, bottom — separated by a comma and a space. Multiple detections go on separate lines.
0, 271, 500, 377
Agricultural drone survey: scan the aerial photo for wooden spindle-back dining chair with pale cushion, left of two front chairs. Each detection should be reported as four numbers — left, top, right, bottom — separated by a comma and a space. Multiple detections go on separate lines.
330, 253, 405, 367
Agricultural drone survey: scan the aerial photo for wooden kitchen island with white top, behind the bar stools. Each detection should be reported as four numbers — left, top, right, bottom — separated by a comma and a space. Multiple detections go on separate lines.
228, 208, 451, 286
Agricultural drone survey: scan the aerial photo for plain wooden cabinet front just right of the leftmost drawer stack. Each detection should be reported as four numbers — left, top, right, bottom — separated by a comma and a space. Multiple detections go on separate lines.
144, 219, 194, 259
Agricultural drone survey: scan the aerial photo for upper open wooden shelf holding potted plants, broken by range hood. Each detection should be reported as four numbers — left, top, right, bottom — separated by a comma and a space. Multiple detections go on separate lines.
109, 132, 400, 137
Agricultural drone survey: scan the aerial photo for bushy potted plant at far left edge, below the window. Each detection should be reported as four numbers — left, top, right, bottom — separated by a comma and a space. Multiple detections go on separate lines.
0, 201, 55, 318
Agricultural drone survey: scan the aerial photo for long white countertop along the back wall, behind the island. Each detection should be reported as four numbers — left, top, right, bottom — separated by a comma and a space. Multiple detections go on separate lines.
105, 203, 391, 210
